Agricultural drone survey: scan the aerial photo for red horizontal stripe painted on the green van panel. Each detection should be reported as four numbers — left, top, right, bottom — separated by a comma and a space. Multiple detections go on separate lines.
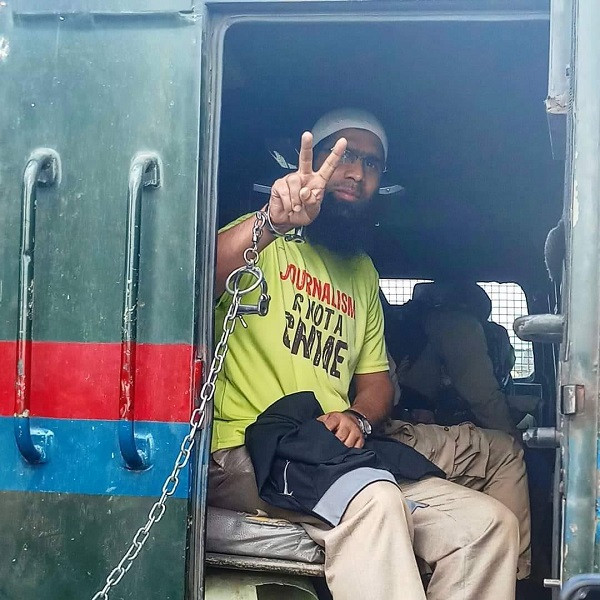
0, 341, 194, 422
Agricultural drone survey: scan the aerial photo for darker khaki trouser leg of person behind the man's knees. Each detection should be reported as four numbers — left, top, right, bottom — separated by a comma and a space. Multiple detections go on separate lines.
385, 421, 531, 579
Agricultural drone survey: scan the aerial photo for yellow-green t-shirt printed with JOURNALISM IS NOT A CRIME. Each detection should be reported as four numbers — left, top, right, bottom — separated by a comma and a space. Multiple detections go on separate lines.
212, 215, 388, 451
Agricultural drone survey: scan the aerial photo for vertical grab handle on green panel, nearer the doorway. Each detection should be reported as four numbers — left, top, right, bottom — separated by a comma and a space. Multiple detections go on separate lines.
119, 152, 161, 471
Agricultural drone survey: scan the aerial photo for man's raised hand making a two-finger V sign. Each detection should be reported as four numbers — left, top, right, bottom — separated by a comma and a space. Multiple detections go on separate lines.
269, 131, 346, 232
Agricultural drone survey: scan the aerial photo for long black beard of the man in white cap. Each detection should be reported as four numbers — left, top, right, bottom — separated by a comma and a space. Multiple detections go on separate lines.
306, 194, 375, 258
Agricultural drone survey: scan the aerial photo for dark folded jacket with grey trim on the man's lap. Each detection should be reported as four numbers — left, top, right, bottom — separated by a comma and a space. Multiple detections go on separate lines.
246, 392, 445, 525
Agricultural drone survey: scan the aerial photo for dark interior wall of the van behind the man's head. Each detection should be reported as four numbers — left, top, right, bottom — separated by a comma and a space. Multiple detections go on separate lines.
218, 13, 564, 600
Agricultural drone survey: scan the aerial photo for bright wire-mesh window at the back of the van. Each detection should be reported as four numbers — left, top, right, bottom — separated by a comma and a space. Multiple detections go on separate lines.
379, 279, 534, 379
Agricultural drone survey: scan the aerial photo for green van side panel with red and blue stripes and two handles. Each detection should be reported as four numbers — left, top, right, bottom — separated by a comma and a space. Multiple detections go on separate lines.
0, 0, 203, 600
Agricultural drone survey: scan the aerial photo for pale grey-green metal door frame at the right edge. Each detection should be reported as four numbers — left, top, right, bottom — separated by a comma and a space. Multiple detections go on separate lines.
559, 0, 600, 581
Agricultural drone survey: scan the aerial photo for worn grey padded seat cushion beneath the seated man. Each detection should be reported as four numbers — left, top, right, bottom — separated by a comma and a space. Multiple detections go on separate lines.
206, 506, 325, 571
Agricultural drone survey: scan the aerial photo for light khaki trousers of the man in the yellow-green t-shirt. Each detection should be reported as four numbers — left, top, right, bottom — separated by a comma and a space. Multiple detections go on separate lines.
208, 446, 519, 600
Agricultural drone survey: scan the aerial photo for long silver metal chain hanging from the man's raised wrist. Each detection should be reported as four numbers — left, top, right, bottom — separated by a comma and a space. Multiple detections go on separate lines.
92, 212, 266, 600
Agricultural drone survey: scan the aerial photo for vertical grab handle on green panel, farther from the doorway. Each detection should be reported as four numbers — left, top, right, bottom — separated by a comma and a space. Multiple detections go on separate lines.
14, 148, 61, 464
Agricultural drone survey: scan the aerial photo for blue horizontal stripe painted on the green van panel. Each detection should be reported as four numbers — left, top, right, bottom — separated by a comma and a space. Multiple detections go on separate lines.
0, 417, 189, 498
